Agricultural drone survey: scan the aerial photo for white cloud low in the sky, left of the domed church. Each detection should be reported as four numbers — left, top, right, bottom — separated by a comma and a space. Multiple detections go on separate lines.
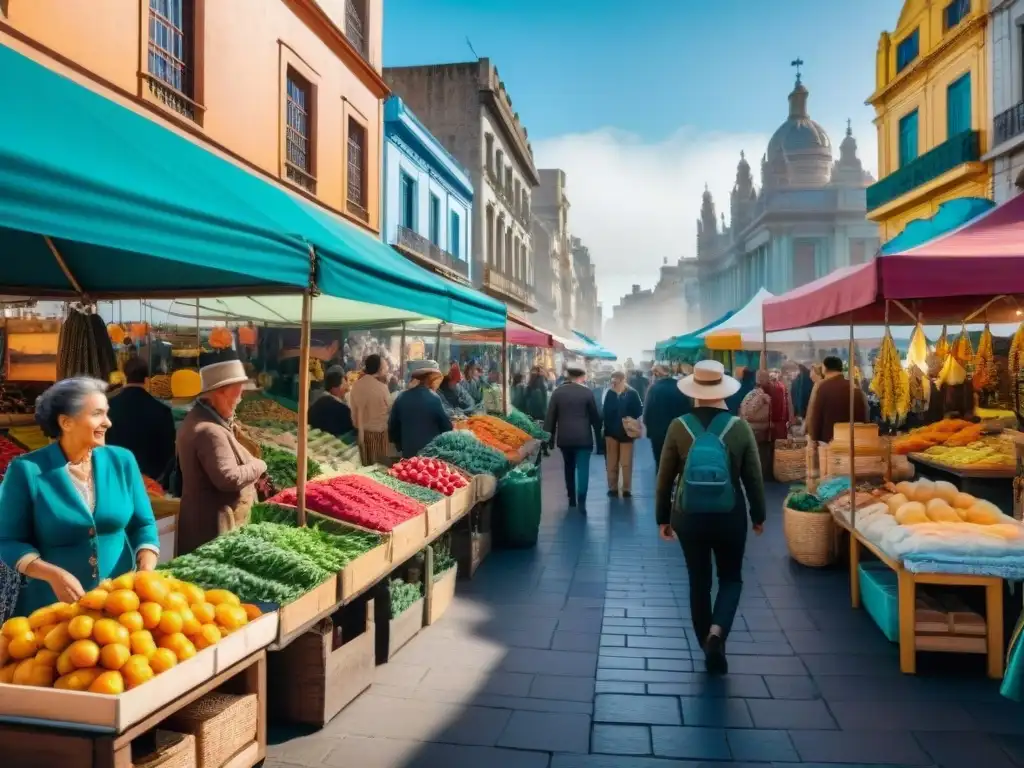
534, 128, 768, 317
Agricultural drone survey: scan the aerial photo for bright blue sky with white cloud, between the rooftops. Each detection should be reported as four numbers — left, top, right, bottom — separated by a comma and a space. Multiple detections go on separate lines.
384, 0, 902, 316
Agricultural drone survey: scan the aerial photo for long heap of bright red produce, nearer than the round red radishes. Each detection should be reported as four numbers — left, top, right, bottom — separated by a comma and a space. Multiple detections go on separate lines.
270, 475, 426, 532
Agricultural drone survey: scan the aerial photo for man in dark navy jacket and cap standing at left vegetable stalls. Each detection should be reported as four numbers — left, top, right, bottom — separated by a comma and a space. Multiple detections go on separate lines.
387, 360, 452, 459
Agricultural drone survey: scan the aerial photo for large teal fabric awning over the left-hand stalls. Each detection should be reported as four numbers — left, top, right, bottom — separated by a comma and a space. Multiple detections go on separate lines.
0, 46, 506, 328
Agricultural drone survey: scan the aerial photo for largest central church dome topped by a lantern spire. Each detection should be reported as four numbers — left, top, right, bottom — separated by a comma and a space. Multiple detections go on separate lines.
762, 68, 833, 187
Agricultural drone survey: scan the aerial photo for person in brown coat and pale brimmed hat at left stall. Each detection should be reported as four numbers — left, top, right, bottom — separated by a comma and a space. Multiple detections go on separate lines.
176, 359, 266, 555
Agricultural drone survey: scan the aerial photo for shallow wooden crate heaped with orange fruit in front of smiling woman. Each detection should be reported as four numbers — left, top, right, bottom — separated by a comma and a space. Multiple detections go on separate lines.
0, 571, 278, 731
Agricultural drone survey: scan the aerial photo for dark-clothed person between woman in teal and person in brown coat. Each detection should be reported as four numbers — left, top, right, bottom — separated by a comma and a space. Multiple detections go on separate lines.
106, 357, 175, 485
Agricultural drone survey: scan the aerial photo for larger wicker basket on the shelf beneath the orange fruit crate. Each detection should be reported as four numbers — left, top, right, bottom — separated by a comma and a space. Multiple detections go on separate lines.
167, 691, 259, 768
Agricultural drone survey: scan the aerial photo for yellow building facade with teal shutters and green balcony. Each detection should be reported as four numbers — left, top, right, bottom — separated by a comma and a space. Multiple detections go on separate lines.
867, 0, 991, 243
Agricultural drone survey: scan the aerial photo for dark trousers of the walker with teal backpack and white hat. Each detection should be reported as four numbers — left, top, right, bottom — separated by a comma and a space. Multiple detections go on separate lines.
676, 513, 746, 644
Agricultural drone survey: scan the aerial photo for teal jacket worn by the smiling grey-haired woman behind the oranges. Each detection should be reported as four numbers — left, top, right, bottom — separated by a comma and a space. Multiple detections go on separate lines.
0, 442, 160, 615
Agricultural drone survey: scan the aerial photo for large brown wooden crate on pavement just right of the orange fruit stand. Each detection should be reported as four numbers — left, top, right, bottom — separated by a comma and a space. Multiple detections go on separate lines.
268, 599, 376, 728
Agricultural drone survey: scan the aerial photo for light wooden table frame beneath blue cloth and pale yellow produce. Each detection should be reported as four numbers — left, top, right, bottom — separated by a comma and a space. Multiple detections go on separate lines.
833, 515, 1005, 680
